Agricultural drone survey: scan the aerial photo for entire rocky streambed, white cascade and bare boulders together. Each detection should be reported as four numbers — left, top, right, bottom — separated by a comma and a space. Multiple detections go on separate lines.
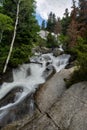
0, 46, 84, 130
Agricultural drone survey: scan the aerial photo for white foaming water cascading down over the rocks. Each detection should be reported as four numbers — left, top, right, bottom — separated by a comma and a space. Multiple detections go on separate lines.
0, 53, 70, 126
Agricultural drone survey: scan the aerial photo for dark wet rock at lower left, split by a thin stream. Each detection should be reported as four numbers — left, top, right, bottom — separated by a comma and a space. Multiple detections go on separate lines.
0, 91, 35, 127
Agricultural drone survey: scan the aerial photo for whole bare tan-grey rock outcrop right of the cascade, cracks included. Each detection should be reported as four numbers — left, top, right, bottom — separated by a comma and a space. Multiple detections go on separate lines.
3, 68, 87, 130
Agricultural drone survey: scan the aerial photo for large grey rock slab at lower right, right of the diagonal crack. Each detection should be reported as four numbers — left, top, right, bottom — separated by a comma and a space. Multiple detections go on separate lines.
49, 82, 87, 130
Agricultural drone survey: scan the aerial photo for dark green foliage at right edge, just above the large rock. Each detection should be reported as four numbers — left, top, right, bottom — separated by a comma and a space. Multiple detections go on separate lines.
67, 38, 87, 87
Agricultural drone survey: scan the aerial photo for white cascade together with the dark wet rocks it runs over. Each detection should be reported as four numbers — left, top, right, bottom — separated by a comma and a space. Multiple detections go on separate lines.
0, 53, 70, 128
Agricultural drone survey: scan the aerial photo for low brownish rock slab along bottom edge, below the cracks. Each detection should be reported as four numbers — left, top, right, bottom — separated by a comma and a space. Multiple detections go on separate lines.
2, 115, 58, 130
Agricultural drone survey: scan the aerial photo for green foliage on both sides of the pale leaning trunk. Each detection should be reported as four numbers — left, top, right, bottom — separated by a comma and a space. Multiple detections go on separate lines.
0, 0, 39, 73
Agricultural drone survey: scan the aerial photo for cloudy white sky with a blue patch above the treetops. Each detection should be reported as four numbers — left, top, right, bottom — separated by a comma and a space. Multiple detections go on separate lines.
36, 0, 78, 23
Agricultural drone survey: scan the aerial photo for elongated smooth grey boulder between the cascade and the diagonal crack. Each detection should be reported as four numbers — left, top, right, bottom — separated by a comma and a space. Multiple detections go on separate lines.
35, 68, 74, 112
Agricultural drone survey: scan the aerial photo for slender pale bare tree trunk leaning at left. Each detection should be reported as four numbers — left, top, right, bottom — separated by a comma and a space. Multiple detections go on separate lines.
3, 0, 21, 73
